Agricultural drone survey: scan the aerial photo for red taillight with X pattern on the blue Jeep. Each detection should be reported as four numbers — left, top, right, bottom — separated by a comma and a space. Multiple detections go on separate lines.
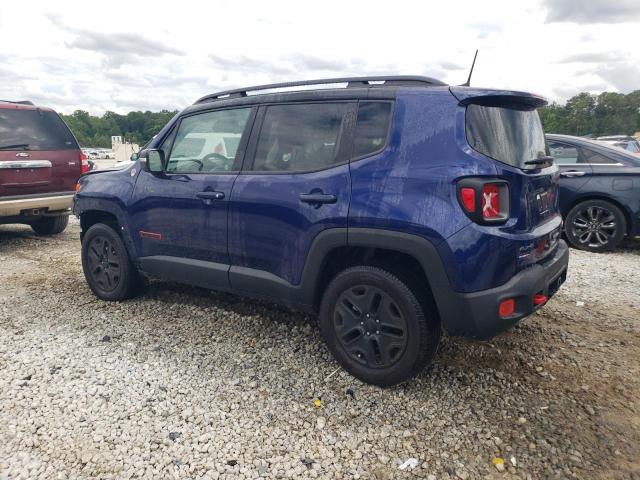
458, 177, 509, 224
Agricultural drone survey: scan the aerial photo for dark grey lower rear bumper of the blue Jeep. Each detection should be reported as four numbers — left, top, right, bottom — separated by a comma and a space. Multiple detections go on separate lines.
434, 240, 569, 339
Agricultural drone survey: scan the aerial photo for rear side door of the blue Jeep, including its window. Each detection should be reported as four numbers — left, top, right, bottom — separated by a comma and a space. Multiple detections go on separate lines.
229, 102, 356, 296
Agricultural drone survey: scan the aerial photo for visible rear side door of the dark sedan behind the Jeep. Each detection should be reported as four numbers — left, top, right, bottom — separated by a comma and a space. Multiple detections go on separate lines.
547, 140, 592, 214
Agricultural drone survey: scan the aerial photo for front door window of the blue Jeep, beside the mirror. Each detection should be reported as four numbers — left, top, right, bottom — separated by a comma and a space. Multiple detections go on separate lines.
165, 108, 251, 173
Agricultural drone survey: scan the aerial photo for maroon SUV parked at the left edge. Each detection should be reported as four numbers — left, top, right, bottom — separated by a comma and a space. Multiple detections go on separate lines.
0, 101, 89, 234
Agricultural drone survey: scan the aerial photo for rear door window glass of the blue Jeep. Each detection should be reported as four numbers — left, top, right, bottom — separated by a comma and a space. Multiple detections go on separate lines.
253, 103, 348, 172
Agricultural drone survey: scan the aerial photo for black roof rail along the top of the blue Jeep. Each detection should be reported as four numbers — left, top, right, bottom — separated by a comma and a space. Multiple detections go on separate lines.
194, 75, 446, 105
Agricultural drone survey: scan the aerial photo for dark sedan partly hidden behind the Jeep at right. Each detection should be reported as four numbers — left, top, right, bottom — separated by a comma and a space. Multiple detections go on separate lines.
547, 134, 640, 252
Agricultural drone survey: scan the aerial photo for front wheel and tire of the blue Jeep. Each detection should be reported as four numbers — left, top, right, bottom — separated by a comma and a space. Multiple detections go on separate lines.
82, 223, 144, 301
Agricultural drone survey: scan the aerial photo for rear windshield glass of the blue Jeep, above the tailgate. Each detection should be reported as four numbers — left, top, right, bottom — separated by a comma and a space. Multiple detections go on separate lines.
466, 104, 546, 169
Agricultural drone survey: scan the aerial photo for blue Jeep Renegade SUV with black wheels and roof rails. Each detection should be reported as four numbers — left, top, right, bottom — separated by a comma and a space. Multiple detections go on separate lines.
74, 77, 568, 386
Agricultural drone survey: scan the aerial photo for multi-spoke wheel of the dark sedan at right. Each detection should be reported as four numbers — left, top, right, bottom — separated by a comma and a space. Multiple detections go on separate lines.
564, 199, 627, 252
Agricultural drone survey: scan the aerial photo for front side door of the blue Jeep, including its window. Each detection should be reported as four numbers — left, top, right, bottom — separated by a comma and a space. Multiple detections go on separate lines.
129, 107, 255, 283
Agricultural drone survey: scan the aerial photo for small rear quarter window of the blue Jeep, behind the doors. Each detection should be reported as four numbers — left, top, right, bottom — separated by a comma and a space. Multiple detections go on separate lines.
352, 102, 391, 158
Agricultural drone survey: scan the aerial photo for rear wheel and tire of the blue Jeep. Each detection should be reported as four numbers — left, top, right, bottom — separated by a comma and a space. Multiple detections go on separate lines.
320, 266, 441, 387
